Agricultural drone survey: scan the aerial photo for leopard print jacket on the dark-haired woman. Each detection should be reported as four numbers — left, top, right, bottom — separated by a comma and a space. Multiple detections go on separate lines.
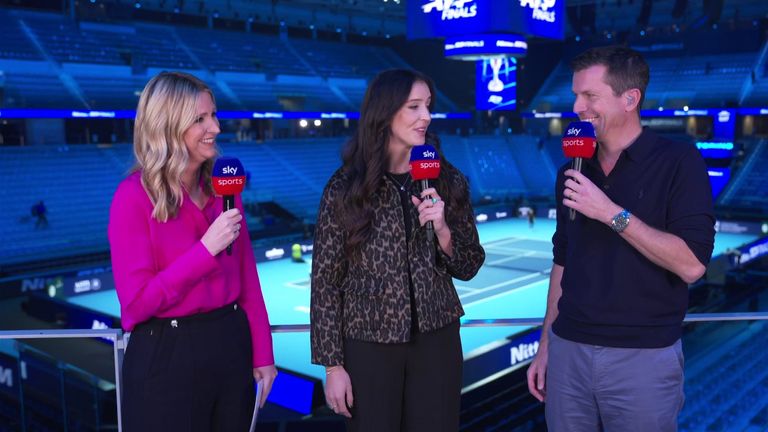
310, 166, 485, 366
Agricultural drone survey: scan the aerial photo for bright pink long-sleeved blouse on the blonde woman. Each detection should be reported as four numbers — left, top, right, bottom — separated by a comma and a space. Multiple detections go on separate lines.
108, 171, 274, 367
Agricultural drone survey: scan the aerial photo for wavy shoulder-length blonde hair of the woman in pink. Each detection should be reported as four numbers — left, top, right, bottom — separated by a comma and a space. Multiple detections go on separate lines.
132, 72, 216, 222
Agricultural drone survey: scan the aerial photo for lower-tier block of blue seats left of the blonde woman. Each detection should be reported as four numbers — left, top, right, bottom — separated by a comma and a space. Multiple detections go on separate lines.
0, 146, 124, 264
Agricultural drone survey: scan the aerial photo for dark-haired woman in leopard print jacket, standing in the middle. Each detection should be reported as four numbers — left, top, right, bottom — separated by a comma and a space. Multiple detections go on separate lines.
311, 70, 485, 432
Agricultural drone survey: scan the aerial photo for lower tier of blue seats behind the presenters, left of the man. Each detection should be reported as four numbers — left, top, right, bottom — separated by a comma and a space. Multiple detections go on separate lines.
0, 136, 556, 265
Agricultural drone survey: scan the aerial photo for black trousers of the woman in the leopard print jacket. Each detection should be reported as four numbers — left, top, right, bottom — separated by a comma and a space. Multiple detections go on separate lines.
344, 322, 463, 432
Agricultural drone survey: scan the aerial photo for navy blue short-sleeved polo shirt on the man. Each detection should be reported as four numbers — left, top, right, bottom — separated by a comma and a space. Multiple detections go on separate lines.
552, 129, 715, 348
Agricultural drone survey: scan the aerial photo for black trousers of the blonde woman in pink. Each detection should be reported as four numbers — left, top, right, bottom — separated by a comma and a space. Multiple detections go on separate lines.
123, 305, 256, 432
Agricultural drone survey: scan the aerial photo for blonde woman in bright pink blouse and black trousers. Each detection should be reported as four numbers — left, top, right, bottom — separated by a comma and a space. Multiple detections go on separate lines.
109, 72, 277, 432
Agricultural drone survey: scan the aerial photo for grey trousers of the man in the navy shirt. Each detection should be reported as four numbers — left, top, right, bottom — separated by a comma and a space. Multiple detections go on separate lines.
545, 331, 685, 432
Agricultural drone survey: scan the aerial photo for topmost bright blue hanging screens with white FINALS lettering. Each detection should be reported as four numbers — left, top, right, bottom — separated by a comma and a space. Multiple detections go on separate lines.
408, 0, 565, 39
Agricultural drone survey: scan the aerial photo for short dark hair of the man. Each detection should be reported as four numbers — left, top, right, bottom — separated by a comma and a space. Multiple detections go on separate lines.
571, 45, 651, 111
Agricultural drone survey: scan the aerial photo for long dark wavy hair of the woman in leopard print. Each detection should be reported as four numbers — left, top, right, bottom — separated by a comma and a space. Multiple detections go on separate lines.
337, 69, 469, 259
